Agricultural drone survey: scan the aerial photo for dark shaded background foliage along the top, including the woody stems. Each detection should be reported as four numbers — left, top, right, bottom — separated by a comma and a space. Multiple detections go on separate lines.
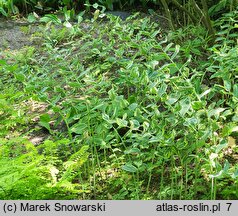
0, 0, 238, 47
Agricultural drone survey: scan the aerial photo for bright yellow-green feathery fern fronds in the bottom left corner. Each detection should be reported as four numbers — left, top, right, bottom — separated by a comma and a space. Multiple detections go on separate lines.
0, 138, 88, 199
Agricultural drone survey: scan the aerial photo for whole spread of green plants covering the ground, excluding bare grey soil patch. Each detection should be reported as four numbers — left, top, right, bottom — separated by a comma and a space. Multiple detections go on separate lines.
0, 0, 238, 199
